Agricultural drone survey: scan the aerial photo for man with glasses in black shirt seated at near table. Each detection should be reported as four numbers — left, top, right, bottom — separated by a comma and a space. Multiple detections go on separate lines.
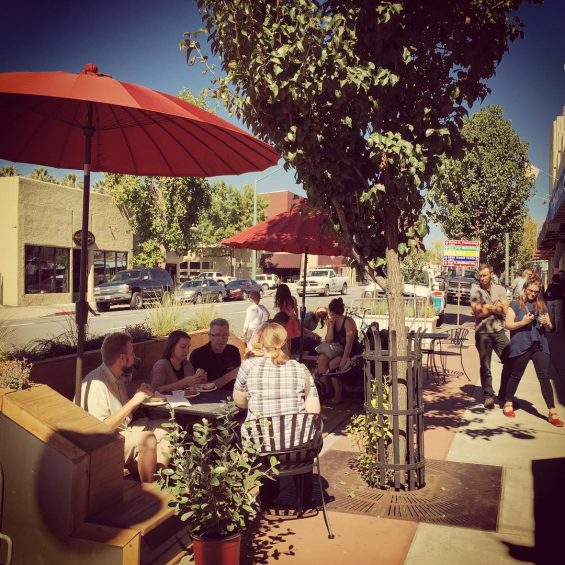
190, 318, 241, 388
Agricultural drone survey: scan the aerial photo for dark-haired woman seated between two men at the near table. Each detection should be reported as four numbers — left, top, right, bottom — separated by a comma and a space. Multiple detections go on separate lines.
150, 330, 208, 393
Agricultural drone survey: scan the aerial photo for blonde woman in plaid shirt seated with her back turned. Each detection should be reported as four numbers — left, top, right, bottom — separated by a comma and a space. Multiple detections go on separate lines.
233, 322, 321, 506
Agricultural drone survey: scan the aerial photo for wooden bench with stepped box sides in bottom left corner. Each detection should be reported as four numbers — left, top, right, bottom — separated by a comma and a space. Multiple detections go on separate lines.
0, 385, 189, 565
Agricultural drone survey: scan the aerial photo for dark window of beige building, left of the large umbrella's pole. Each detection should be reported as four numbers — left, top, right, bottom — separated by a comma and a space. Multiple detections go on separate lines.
24, 245, 70, 294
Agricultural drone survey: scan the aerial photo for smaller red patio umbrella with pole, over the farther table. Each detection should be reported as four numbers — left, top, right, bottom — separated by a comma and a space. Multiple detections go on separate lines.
221, 199, 347, 358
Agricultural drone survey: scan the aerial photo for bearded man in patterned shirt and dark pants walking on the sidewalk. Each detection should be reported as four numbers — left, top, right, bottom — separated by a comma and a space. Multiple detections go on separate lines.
471, 263, 510, 409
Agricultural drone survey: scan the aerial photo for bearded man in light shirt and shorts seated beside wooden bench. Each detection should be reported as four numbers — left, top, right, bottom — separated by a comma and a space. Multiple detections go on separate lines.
81, 332, 169, 483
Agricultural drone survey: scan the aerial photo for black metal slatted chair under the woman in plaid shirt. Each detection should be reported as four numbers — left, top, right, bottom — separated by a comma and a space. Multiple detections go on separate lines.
246, 413, 335, 539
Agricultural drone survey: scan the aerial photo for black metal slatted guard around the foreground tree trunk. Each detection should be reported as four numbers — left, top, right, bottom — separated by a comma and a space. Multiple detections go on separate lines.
363, 324, 425, 490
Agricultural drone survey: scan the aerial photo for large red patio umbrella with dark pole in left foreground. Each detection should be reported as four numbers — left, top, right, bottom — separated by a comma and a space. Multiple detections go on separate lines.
0, 64, 279, 403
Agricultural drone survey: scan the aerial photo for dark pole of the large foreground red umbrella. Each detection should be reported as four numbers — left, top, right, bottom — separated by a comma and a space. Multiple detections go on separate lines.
75, 102, 94, 406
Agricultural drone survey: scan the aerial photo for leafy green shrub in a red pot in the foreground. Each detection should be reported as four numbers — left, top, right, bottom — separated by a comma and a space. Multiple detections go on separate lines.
159, 403, 277, 565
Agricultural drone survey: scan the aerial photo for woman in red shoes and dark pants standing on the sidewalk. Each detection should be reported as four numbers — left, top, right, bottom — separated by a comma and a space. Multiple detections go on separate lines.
502, 275, 563, 428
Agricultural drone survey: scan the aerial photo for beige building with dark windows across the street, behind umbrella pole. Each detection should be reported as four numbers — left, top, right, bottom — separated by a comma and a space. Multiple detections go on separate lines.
0, 177, 133, 306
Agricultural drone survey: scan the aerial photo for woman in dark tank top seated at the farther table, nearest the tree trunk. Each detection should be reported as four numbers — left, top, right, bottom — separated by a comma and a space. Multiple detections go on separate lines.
318, 297, 363, 404
